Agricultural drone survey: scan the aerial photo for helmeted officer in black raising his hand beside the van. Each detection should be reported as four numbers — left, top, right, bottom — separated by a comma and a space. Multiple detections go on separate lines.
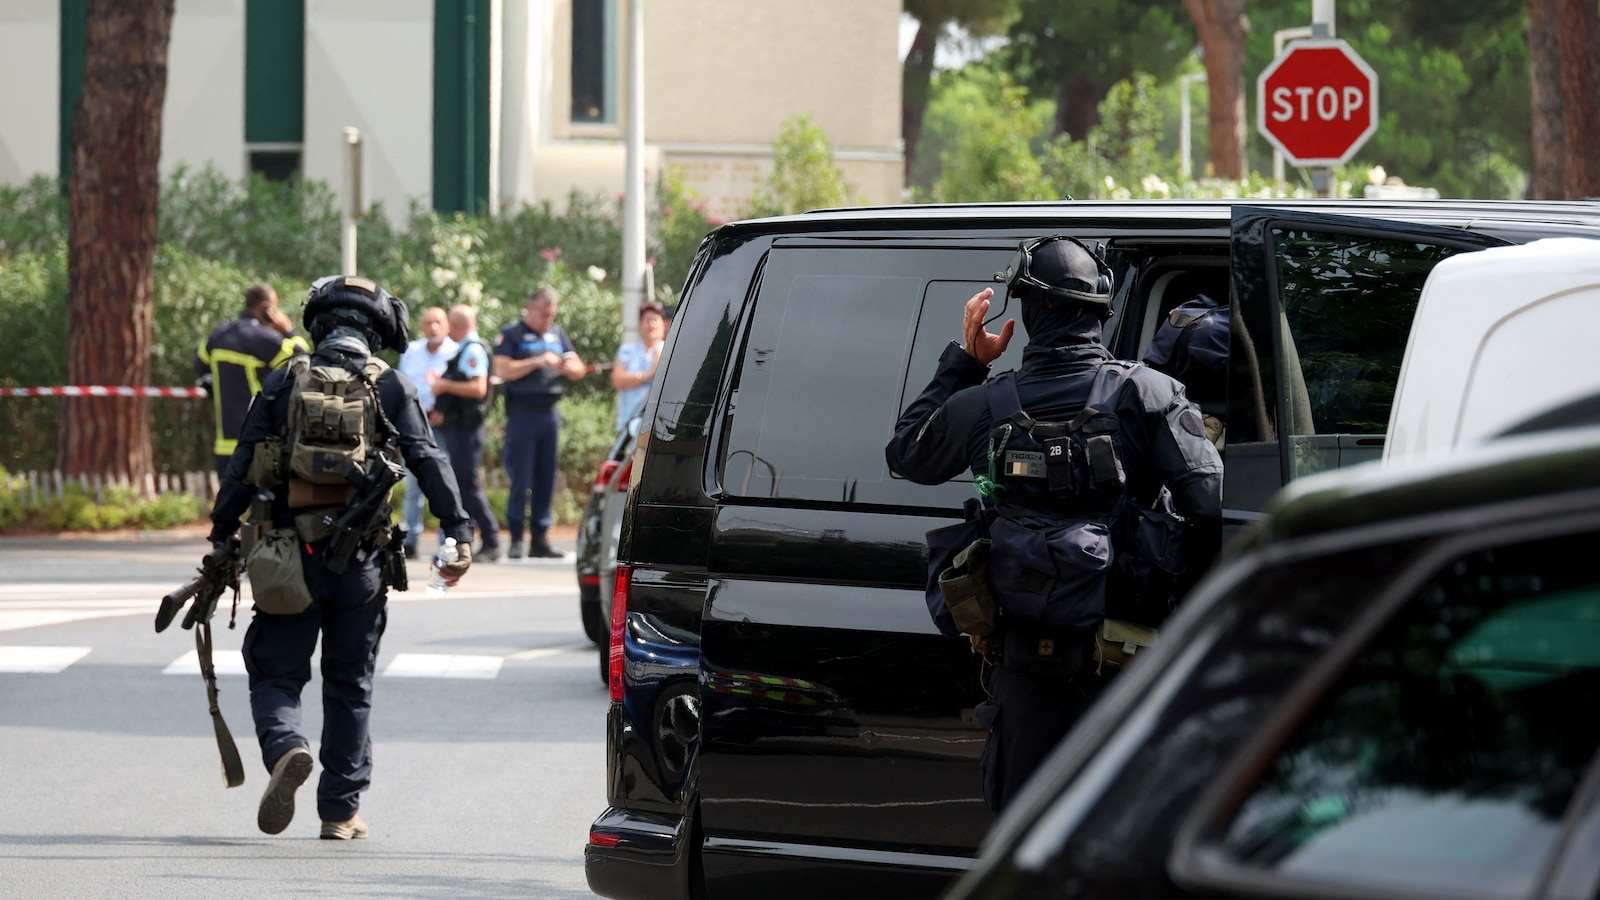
885, 235, 1222, 810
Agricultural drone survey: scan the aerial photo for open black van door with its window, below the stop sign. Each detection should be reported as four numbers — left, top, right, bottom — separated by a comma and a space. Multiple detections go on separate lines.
1222, 207, 1507, 525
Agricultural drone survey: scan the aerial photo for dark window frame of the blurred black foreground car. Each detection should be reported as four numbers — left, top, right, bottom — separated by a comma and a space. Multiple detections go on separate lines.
1168, 488, 1600, 900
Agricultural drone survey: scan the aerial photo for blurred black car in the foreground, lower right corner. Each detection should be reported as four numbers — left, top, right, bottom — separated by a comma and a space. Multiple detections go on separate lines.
949, 428, 1600, 900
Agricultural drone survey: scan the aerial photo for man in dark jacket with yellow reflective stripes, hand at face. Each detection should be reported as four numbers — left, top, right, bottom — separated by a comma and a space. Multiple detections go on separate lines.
195, 283, 310, 474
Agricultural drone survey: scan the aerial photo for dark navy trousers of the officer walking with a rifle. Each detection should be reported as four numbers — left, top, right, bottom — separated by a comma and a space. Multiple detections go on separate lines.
243, 544, 387, 822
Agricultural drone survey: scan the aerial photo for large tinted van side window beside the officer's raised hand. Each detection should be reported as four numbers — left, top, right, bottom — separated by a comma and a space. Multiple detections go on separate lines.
720, 247, 1026, 509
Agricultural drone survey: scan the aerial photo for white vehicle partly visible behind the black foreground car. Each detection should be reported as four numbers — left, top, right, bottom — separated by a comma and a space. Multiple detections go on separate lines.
1382, 237, 1600, 464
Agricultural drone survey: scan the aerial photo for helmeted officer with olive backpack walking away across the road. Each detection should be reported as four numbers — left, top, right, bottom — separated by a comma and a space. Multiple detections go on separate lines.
211, 275, 472, 839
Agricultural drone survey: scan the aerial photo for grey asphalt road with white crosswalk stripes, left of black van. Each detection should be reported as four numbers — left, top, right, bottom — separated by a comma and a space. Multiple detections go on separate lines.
0, 528, 606, 900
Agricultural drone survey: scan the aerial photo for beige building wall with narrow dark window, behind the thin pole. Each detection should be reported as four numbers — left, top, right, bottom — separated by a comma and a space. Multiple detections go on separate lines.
533, 0, 904, 218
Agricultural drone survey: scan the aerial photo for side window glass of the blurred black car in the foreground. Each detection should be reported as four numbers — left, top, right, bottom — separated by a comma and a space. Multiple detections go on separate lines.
1221, 533, 1600, 897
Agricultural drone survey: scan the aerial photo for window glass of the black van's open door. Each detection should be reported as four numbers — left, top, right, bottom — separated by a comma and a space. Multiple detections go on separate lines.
1272, 229, 1461, 477
